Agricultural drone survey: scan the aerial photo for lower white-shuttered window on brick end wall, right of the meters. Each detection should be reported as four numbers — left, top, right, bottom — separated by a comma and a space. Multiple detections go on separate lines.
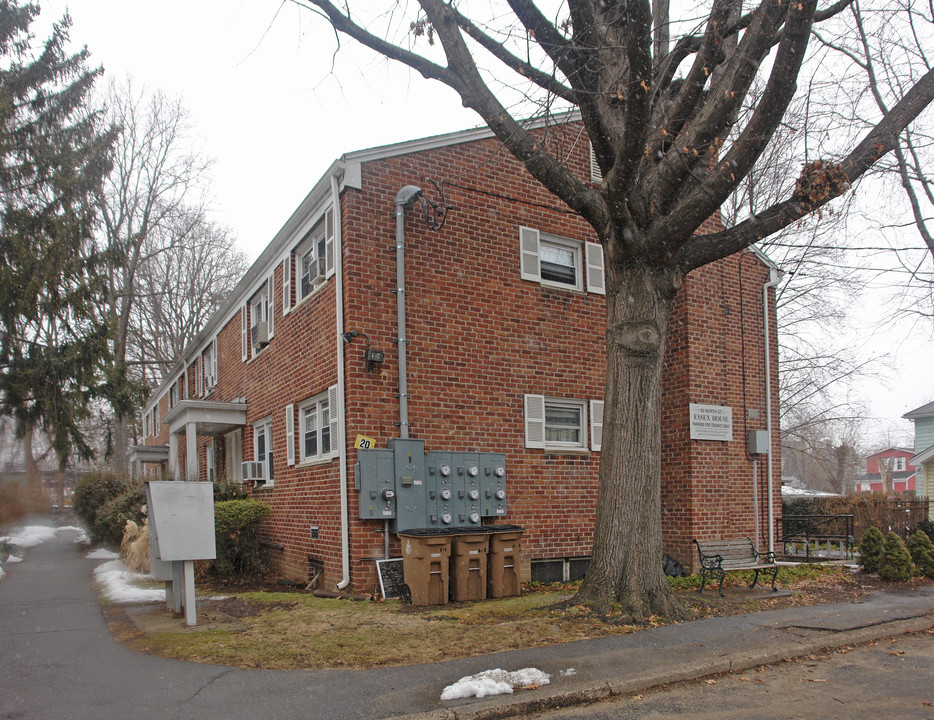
523, 395, 603, 451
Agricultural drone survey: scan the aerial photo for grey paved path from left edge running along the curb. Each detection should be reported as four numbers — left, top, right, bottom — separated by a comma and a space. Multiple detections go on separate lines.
0, 532, 934, 720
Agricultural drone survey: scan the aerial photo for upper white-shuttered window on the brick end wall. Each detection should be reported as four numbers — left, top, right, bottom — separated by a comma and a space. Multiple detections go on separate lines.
519, 227, 606, 295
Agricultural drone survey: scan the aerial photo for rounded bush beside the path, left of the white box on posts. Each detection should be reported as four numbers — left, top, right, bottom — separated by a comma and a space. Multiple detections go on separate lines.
72, 472, 146, 546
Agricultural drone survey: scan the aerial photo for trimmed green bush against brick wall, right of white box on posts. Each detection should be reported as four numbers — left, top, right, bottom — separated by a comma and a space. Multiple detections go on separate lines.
212, 499, 271, 580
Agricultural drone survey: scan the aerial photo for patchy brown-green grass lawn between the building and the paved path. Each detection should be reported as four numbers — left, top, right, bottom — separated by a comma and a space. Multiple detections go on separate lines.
113, 565, 929, 669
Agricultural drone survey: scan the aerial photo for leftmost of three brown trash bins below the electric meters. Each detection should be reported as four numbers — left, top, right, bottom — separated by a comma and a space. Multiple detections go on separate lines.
397, 528, 451, 605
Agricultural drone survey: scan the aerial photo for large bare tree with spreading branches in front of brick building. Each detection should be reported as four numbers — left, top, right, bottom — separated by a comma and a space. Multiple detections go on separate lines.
302, 0, 934, 621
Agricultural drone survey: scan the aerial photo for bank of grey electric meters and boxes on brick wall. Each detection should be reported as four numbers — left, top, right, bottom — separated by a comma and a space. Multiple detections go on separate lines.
354, 439, 507, 532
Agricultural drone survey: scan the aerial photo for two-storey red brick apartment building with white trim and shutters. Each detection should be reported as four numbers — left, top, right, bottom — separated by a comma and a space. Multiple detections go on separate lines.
132, 118, 781, 590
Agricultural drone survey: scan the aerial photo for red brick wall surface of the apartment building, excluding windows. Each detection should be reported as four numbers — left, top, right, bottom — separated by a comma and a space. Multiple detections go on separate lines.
141, 124, 781, 590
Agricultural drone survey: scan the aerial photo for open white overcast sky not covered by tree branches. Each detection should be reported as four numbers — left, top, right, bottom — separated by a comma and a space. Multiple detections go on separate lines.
37, 0, 934, 442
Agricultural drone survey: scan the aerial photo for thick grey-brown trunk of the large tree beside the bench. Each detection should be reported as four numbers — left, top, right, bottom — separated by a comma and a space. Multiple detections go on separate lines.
576, 256, 686, 623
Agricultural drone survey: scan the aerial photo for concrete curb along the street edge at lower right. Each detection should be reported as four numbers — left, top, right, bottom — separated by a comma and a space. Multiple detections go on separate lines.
384, 612, 934, 720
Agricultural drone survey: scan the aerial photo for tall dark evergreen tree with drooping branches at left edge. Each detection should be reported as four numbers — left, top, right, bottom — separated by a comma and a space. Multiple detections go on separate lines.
0, 0, 130, 478
